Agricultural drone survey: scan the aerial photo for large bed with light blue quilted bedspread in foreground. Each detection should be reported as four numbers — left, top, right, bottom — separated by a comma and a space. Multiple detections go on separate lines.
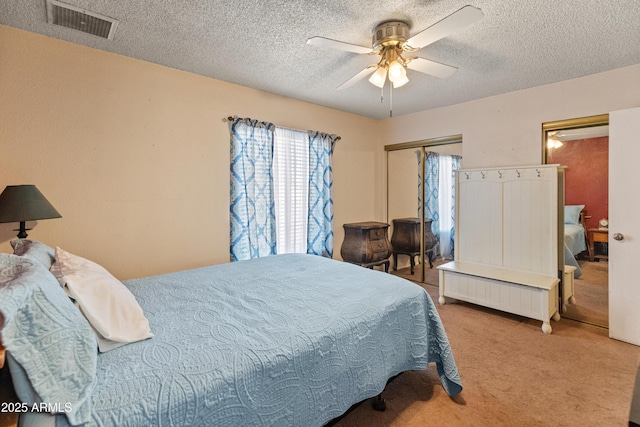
0, 244, 462, 426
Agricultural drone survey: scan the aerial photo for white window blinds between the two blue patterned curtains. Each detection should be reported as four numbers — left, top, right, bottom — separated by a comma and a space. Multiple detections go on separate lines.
273, 127, 309, 254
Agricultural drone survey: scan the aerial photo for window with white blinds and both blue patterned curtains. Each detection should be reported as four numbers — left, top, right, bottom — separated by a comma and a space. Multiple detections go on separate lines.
229, 117, 339, 261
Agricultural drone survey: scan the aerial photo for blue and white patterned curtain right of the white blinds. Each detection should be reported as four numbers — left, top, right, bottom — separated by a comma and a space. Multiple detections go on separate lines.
307, 131, 338, 258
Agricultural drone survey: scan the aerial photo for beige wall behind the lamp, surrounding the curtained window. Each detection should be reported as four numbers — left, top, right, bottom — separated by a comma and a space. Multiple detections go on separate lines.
0, 26, 384, 279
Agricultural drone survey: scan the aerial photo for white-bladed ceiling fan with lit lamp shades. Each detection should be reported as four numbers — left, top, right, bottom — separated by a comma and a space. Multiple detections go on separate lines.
307, 5, 483, 89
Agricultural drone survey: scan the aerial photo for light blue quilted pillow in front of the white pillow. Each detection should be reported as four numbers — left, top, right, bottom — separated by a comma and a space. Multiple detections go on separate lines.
0, 254, 97, 425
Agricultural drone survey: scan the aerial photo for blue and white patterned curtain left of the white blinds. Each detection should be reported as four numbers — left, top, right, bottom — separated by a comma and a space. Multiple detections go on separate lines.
230, 118, 276, 261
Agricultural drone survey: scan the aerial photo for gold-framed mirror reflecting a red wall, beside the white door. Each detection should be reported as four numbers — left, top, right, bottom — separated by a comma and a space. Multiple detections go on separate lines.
546, 122, 609, 328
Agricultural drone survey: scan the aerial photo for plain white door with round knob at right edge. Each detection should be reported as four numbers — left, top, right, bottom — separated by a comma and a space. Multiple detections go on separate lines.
609, 108, 640, 345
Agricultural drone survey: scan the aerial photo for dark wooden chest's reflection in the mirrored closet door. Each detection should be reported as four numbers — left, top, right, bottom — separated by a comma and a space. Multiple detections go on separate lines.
391, 218, 436, 274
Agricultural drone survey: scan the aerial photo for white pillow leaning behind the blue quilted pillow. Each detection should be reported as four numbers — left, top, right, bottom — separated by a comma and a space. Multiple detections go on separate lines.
51, 247, 153, 351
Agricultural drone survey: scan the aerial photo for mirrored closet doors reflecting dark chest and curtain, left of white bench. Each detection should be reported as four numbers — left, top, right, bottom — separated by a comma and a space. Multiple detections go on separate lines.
385, 135, 462, 285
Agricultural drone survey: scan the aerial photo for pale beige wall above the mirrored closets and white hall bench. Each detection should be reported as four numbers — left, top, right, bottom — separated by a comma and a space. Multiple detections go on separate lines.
380, 64, 640, 168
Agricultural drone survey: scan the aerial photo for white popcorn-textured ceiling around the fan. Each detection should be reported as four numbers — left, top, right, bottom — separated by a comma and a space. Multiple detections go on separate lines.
0, 0, 640, 119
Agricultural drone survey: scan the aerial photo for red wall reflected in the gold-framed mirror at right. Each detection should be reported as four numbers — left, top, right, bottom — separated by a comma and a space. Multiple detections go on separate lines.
547, 136, 609, 228
